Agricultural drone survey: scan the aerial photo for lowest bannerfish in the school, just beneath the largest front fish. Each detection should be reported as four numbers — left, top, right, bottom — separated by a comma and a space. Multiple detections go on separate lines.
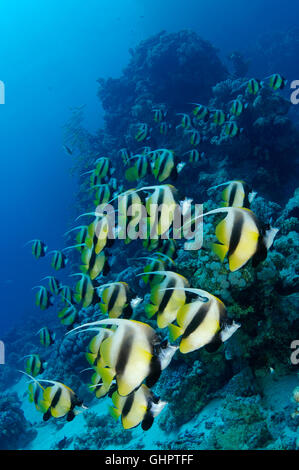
109, 384, 167, 431
